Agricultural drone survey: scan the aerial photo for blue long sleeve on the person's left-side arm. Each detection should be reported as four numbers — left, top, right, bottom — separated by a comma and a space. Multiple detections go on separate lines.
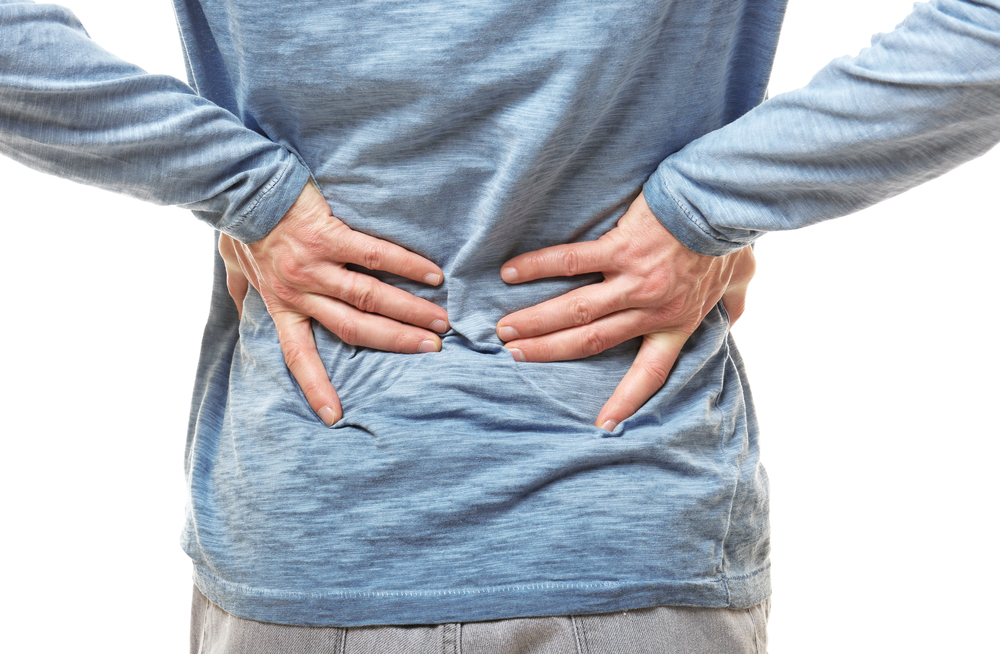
0, 0, 309, 242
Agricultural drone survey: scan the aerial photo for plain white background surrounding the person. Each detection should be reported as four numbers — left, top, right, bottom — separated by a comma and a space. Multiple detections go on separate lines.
0, 0, 1000, 654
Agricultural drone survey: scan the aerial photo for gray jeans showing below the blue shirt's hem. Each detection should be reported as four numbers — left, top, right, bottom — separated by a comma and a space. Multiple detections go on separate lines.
191, 588, 770, 654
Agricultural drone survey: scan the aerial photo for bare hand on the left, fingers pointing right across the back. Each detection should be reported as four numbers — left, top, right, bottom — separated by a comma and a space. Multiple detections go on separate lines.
219, 182, 448, 426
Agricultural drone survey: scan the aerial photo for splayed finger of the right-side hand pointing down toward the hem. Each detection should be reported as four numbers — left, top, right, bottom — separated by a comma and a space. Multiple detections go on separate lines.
594, 331, 688, 431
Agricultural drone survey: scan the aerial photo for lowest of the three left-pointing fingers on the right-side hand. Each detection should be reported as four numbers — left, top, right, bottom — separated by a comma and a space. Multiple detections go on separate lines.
504, 309, 651, 362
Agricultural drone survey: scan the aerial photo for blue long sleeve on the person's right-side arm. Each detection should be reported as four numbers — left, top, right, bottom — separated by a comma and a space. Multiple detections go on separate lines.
644, 0, 1000, 255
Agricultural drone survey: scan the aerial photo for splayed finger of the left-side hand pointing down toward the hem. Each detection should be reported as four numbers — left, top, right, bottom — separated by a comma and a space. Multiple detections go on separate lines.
273, 312, 343, 427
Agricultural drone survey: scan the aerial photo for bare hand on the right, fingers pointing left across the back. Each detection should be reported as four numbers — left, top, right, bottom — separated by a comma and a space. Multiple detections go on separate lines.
497, 193, 756, 431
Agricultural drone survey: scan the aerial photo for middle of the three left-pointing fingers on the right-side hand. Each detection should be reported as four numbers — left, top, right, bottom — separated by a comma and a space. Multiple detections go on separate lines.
497, 281, 629, 341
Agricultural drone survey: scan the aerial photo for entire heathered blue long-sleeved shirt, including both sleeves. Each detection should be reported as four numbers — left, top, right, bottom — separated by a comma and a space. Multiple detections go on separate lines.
0, 0, 1000, 626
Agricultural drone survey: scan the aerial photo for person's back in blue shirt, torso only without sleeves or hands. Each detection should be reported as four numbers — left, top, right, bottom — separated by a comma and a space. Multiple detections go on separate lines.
180, 2, 781, 624
